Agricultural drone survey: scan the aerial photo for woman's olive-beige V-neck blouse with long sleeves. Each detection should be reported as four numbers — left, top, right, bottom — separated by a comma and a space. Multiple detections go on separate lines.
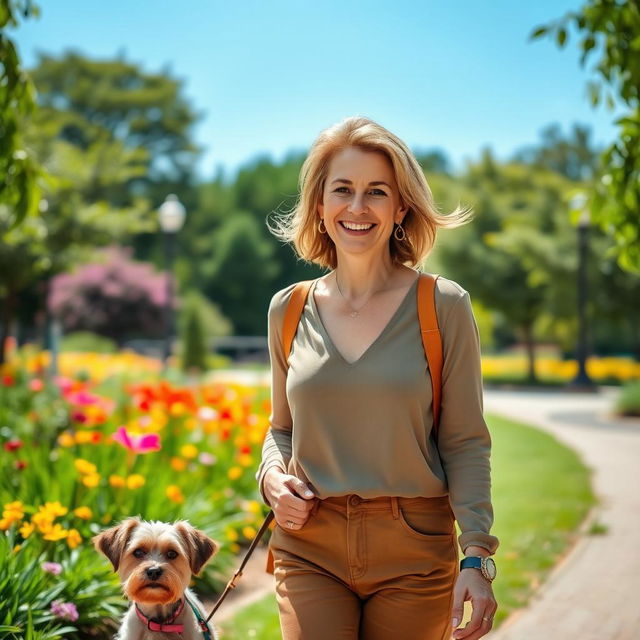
256, 276, 499, 554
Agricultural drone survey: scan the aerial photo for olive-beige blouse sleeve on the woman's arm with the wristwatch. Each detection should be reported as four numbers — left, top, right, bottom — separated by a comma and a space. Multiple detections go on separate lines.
438, 289, 499, 555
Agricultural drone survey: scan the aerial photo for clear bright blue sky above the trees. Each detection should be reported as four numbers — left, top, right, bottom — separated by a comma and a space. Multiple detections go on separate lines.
14, 0, 615, 178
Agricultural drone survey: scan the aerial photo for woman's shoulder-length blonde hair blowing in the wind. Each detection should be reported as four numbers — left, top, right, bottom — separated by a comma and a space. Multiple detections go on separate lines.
267, 116, 473, 269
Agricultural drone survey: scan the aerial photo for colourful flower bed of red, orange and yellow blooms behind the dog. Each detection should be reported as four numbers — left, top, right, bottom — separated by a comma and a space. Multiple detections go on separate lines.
0, 354, 270, 638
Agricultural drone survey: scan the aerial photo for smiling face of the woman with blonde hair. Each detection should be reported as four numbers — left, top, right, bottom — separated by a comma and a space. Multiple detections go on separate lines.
318, 147, 406, 260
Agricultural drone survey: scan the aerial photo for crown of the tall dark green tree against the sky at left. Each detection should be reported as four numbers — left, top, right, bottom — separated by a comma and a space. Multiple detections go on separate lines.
32, 51, 199, 206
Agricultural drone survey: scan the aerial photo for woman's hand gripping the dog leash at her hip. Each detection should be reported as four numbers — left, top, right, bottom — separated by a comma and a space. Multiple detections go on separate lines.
264, 467, 317, 530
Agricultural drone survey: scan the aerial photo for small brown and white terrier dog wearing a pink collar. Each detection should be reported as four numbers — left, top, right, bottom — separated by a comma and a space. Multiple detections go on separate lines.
92, 517, 218, 640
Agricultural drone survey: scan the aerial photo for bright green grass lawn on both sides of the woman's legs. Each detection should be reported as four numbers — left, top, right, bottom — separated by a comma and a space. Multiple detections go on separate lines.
223, 414, 595, 640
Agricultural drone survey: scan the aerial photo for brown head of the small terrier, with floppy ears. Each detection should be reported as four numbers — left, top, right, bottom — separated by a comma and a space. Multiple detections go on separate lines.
93, 518, 218, 604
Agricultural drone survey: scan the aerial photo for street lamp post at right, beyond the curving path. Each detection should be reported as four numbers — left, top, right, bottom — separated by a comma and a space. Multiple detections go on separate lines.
571, 193, 594, 389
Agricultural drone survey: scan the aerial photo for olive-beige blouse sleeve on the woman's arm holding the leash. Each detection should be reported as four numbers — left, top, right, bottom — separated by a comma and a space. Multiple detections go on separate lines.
256, 285, 294, 504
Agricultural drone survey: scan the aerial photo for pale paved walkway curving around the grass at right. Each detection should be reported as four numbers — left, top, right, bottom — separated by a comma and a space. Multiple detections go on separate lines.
485, 389, 640, 640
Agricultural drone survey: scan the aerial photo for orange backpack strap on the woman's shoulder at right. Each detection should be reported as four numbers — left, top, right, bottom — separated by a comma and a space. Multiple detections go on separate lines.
418, 273, 443, 442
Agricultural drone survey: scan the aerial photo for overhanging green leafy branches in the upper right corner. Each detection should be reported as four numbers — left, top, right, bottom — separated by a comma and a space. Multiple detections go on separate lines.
531, 0, 640, 273
